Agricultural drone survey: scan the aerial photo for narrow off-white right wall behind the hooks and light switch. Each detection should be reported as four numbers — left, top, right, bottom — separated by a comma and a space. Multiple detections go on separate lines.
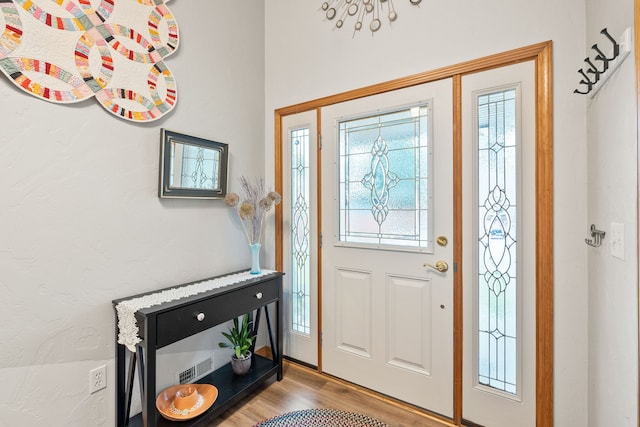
586, 0, 638, 427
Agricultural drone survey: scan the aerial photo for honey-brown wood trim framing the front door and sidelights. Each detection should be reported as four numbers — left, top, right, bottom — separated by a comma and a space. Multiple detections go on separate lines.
274, 41, 552, 427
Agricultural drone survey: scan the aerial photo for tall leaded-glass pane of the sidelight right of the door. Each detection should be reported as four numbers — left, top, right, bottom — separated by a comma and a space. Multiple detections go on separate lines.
476, 88, 520, 395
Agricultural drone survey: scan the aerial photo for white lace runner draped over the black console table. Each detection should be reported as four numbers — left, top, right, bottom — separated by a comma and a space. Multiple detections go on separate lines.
116, 270, 274, 352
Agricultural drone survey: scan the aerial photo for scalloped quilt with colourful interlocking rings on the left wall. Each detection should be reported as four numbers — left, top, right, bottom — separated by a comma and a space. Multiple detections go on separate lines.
0, 0, 178, 122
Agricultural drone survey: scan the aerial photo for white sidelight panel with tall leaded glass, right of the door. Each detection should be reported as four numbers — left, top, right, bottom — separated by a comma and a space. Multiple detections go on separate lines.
462, 61, 536, 427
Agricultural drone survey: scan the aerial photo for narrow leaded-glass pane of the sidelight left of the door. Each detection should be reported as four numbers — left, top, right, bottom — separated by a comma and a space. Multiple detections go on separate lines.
290, 128, 311, 335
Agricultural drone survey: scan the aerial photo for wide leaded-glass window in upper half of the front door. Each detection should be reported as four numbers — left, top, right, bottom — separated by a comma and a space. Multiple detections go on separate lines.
338, 103, 432, 250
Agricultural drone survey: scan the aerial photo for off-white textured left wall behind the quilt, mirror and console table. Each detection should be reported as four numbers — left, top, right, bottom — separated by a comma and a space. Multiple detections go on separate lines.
0, 0, 265, 427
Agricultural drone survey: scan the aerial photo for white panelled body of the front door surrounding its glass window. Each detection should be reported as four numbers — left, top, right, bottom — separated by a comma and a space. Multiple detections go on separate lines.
321, 79, 453, 416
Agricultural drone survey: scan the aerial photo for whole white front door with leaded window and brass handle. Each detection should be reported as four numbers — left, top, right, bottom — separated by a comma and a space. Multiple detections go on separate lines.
321, 79, 454, 417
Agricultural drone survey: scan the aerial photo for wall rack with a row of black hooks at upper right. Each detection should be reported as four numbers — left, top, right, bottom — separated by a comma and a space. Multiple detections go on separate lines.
573, 28, 631, 98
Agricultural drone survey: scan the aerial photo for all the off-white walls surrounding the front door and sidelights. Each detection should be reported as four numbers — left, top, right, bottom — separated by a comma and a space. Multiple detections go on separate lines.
5, 0, 637, 427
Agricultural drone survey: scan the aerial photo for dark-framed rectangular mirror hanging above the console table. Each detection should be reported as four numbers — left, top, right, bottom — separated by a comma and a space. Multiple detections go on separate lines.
158, 129, 229, 199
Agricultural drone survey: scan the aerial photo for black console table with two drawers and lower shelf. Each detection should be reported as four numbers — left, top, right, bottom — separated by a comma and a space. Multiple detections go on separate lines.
113, 272, 283, 427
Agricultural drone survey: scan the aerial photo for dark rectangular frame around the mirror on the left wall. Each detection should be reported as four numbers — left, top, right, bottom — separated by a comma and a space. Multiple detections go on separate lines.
158, 129, 229, 199
